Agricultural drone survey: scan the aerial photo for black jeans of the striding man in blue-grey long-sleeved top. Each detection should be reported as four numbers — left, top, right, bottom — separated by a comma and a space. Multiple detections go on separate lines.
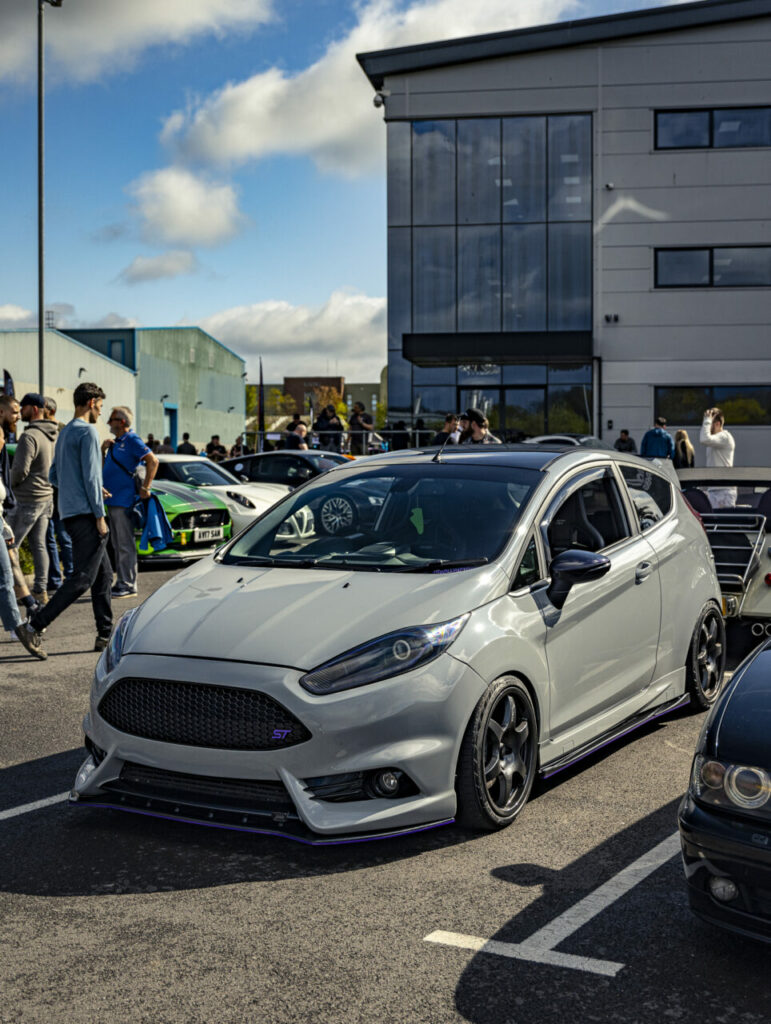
30, 515, 113, 636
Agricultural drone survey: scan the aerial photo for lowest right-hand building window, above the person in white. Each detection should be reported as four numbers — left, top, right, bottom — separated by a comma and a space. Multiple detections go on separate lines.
654, 385, 771, 429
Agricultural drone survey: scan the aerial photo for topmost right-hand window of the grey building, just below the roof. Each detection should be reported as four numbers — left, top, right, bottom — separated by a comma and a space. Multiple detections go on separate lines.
655, 106, 771, 150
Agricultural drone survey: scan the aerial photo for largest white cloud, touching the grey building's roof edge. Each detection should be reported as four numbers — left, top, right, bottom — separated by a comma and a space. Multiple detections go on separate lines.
162, 0, 581, 176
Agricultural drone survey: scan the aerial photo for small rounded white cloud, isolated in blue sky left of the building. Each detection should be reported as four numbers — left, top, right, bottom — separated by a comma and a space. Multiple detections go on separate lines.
128, 167, 244, 246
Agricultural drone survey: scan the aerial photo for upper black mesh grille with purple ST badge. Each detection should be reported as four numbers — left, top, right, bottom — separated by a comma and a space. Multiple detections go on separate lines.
99, 678, 310, 751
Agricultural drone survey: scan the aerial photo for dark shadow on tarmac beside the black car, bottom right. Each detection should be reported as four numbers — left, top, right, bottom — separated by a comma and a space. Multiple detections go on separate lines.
450, 799, 771, 1024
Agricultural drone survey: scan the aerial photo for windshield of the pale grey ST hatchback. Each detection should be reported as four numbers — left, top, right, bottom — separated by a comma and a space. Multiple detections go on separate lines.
222, 462, 542, 572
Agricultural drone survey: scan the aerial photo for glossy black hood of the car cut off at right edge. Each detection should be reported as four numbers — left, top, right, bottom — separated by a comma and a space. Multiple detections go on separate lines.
710, 646, 771, 769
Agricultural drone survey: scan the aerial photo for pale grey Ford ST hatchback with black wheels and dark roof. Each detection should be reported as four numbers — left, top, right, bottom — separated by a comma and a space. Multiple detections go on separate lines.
71, 445, 725, 843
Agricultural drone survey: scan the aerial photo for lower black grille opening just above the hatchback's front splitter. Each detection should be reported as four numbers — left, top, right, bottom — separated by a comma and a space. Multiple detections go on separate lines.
103, 761, 294, 811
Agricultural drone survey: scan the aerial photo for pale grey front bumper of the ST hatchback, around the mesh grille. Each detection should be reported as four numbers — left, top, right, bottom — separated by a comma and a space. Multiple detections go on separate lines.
71, 653, 484, 844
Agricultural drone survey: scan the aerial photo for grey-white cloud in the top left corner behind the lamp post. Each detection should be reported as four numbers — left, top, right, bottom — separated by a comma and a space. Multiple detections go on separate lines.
0, 0, 273, 81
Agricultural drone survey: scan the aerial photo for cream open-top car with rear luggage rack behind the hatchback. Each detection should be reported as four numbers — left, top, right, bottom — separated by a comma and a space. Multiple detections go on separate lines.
677, 466, 771, 654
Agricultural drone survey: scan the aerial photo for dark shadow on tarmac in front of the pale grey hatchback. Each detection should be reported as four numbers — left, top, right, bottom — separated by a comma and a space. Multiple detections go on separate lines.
0, 748, 474, 896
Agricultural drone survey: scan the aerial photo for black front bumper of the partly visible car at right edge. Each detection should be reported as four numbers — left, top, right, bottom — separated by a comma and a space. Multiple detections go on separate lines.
678, 794, 771, 942
